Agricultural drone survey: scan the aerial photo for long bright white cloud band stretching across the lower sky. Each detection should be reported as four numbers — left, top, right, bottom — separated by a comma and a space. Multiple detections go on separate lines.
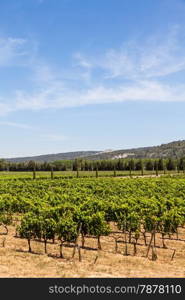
7, 80, 185, 110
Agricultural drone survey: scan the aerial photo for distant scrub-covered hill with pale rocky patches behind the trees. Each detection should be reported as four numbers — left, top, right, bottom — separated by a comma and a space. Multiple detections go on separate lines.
3, 140, 185, 162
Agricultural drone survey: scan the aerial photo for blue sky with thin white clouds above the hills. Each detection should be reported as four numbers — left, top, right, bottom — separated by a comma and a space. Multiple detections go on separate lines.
0, 0, 185, 158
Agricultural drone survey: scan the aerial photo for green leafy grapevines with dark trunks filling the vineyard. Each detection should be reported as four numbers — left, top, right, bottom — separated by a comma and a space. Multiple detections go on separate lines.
0, 176, 185, 260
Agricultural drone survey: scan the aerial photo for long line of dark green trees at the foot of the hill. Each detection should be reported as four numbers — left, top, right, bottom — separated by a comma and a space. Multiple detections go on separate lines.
0, 157, 185, 172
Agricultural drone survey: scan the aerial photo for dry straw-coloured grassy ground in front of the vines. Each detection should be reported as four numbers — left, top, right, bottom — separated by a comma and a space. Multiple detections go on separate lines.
0, 227, 185, 278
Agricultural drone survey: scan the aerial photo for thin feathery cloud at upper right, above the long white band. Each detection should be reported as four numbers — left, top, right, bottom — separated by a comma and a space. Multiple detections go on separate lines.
76, 26, 185, 80
